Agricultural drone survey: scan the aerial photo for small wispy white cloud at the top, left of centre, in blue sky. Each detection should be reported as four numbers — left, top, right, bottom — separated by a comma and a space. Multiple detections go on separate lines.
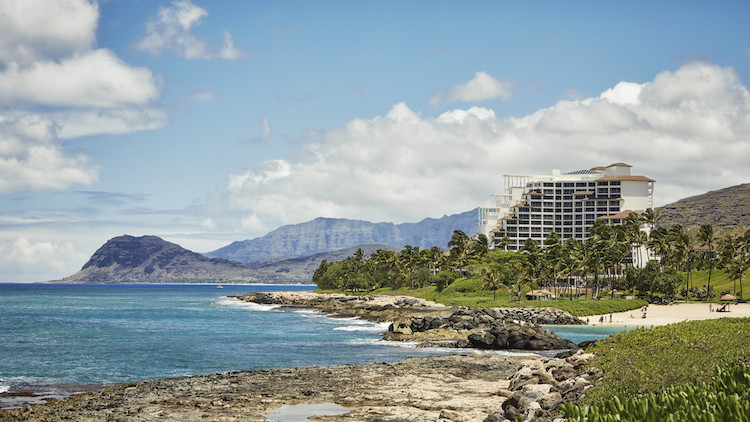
134, 0, 244, 60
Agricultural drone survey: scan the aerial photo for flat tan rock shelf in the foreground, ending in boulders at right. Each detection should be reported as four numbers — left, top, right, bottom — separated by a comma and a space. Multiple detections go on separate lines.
0, 352, 596, 422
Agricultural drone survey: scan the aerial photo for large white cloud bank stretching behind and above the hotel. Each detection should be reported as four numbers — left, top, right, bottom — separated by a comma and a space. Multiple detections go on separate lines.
227, 63, 750, 234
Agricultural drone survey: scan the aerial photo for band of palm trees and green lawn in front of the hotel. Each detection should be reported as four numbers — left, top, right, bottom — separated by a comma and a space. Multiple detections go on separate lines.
313, 209, 750, 316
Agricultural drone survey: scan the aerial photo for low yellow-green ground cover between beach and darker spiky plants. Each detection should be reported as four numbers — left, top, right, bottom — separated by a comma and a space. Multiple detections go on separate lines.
584, 318, 750, 404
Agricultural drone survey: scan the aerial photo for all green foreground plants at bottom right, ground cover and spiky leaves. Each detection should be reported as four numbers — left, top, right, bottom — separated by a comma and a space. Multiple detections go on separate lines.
563, 318, 750, 422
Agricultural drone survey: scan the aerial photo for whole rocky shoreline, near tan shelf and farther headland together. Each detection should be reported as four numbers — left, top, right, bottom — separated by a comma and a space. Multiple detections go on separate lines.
0, 292, 601, 422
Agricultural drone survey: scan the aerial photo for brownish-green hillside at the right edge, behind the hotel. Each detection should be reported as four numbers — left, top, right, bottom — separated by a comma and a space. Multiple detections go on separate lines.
658, 183, 750, 235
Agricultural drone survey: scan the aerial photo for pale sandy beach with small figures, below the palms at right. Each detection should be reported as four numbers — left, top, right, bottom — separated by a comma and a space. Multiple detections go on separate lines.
583, 303, 750, 327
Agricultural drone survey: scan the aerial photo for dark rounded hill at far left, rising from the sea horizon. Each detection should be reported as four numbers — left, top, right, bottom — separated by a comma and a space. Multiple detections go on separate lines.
60, 236, 261, 283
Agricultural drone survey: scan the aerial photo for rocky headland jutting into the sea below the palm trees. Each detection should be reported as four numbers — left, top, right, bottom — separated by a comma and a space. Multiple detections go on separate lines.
238, 292, 583, 350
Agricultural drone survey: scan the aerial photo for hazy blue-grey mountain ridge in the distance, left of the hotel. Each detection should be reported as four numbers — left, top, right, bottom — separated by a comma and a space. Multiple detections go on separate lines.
205, 209, 477, 268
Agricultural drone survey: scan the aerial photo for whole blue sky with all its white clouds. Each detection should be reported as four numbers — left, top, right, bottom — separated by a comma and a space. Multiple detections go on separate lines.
0, 0, 750, 281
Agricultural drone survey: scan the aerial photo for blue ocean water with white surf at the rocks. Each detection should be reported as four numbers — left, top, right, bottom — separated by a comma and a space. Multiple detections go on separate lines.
0, 284, 620, 408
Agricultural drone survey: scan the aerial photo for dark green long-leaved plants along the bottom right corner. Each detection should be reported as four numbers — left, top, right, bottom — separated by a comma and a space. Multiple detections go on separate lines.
562, 365, 750, 422
